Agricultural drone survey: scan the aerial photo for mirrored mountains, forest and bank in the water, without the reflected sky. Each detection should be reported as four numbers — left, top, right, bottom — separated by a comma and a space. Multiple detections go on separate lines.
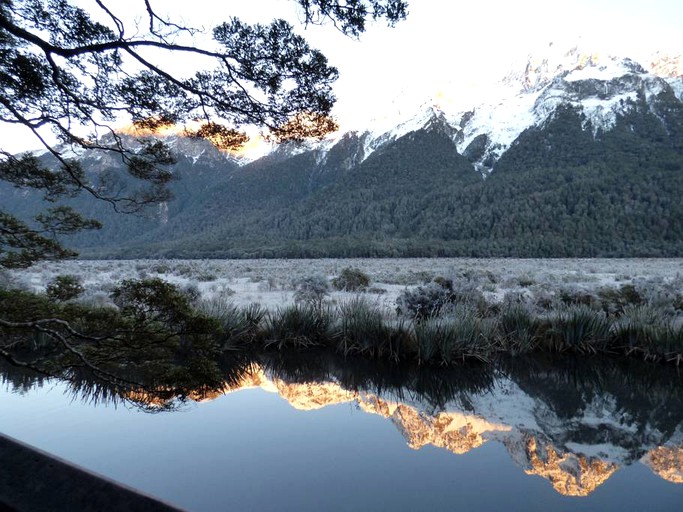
1, 352, 683, 496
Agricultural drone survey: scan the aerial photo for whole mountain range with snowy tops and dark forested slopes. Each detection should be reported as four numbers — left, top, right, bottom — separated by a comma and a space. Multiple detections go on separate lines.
0, 51, 683, 257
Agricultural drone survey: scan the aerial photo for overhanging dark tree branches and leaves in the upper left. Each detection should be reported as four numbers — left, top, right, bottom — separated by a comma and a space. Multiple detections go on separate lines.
0, 0, 406, 267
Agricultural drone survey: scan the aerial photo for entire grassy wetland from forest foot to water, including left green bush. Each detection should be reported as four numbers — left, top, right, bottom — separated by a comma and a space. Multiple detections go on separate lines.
0, 259, 683, 372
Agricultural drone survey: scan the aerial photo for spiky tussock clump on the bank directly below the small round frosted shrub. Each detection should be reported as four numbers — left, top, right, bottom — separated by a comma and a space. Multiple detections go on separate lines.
265, 304, 334, 349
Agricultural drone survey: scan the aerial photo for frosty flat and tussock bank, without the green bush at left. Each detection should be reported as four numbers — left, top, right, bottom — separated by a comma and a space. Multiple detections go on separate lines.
0, 258, 683, 365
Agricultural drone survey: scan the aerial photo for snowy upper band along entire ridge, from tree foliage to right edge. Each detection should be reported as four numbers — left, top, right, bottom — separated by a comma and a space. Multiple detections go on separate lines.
42, 45, 683, 175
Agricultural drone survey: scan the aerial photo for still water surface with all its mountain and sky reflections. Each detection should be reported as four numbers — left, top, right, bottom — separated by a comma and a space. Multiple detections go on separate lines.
0, 354, 683, 511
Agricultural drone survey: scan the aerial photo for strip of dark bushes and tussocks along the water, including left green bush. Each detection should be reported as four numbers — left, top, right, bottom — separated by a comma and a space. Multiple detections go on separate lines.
0, 269, 683, 372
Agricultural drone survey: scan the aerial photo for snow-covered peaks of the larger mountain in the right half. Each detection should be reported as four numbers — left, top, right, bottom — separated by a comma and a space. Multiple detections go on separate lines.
344, 47, 683, 173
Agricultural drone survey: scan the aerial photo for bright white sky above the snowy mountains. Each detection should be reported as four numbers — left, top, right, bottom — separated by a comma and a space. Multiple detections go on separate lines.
0, 0, 683, 151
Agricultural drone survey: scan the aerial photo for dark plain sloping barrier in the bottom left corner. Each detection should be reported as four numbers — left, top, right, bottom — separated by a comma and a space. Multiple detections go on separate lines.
0, 434, 181, 512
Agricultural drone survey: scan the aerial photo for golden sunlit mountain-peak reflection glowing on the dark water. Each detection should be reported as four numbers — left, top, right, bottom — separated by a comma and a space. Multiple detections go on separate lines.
120, 365, 683, 496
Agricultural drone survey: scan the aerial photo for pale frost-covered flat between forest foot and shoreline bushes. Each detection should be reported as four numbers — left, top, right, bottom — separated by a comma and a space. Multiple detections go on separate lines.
6, 258, 683, 310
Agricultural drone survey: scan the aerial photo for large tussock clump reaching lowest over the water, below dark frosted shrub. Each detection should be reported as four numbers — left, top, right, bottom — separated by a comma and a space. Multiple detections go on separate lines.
415, 306, 495, 365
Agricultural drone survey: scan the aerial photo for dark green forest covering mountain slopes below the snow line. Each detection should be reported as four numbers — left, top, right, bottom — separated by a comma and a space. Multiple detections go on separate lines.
5, 92, 683, 258
